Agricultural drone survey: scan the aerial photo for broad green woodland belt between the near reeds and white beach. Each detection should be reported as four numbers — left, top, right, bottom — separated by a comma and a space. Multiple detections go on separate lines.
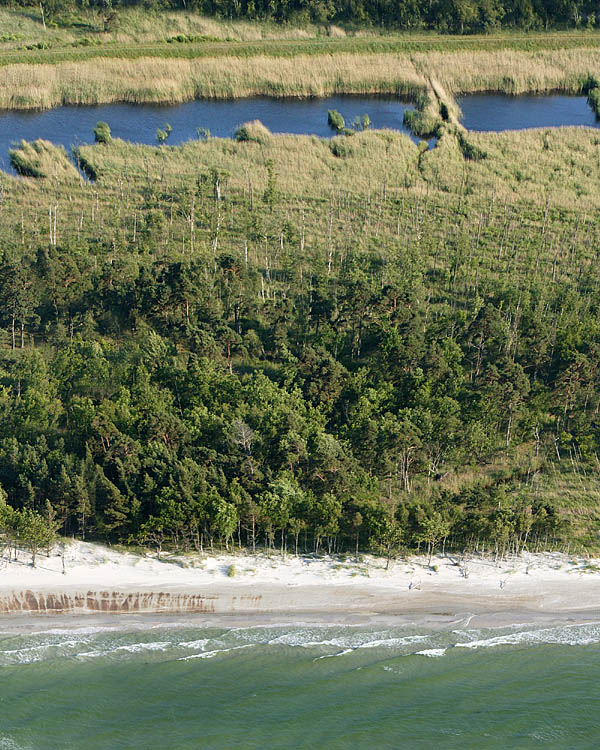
0, 123, 600, 553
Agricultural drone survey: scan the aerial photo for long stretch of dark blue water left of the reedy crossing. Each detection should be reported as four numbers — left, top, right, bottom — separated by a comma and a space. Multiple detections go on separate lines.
0, 96, 418, 167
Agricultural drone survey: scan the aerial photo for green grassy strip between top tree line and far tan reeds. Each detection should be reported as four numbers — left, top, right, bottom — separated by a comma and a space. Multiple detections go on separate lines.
0, 20, 600, 65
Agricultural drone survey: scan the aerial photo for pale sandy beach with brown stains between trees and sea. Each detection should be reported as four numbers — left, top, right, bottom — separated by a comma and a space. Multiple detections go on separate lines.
0, 542, 600, 627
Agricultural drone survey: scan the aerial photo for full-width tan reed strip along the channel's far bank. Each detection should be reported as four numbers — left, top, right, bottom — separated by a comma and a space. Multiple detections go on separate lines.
0, 49, 600, 109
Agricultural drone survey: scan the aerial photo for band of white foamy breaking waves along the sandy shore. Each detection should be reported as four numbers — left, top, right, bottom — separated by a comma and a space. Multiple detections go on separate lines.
0, 623, 600, 668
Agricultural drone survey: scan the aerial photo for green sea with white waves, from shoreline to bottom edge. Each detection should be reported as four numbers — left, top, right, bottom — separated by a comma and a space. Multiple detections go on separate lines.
0, 621, 600, 750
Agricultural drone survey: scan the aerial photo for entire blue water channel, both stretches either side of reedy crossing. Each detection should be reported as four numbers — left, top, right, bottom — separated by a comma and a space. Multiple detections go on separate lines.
0, 93, 600, 171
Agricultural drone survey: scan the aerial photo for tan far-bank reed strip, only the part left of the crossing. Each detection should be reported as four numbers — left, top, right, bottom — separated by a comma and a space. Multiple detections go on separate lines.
0, 55, 426, 109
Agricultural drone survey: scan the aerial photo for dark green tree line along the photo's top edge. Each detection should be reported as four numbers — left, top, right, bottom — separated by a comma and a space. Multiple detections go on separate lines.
1, 0, 600, 34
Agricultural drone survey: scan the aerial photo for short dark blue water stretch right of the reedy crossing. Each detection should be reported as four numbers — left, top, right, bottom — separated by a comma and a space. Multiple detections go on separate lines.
457, 94, 600, 132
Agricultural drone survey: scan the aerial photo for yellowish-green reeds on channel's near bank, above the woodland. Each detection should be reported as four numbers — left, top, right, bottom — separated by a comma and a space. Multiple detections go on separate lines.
68, 124, 600, 211
